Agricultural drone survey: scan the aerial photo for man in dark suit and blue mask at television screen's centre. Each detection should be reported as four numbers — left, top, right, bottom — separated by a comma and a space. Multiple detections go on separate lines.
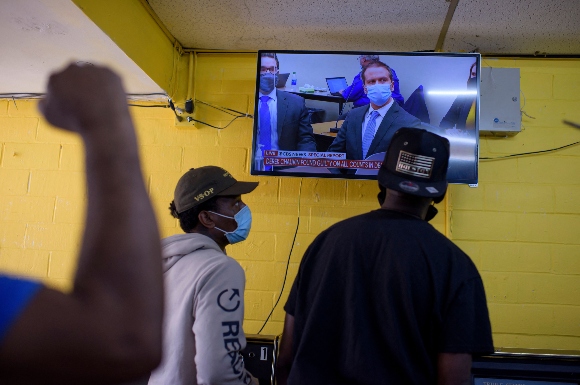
327, 60, 421, 166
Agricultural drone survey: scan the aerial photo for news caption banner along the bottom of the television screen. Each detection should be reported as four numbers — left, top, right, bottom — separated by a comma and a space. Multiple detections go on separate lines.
263, 150, 383, 170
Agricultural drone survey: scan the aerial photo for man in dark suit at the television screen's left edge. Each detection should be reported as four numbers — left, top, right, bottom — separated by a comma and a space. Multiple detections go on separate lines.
255, 53, 316, 160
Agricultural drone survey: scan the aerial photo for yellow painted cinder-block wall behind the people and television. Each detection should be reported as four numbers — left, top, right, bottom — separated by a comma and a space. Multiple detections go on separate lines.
0, 53, 580, 350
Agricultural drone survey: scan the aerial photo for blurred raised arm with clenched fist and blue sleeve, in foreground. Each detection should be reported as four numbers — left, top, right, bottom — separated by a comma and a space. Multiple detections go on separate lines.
0, 64, 163, 384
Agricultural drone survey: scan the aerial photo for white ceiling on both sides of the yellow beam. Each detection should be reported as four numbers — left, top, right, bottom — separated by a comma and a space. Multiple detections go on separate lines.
0, 0, 580, 93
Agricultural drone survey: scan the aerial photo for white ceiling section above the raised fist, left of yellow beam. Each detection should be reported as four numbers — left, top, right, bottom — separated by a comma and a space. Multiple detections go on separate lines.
0, 0, 164, 93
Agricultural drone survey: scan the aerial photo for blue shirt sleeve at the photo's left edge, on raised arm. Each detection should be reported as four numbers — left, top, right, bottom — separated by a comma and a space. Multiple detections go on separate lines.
0, 275, 42, 343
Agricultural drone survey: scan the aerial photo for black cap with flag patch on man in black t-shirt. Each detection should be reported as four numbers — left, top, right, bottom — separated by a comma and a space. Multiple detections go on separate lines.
378, 127, 450, 198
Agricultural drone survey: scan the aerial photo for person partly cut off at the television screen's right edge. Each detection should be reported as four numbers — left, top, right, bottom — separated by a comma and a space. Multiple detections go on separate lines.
439, 63, 477, 131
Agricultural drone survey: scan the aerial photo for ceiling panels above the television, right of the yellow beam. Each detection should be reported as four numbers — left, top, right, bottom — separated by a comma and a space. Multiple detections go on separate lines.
147, 0, 580, 54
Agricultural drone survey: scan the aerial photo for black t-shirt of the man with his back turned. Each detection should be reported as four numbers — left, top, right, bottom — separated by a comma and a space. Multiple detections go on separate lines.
284, 209, 493, 385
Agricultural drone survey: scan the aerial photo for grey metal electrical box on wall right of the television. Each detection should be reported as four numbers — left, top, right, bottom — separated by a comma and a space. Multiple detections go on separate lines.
479, 67, 522, 136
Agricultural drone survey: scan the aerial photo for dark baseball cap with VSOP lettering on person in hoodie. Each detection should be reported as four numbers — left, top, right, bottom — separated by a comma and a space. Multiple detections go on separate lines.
173, 166, 258, 214
